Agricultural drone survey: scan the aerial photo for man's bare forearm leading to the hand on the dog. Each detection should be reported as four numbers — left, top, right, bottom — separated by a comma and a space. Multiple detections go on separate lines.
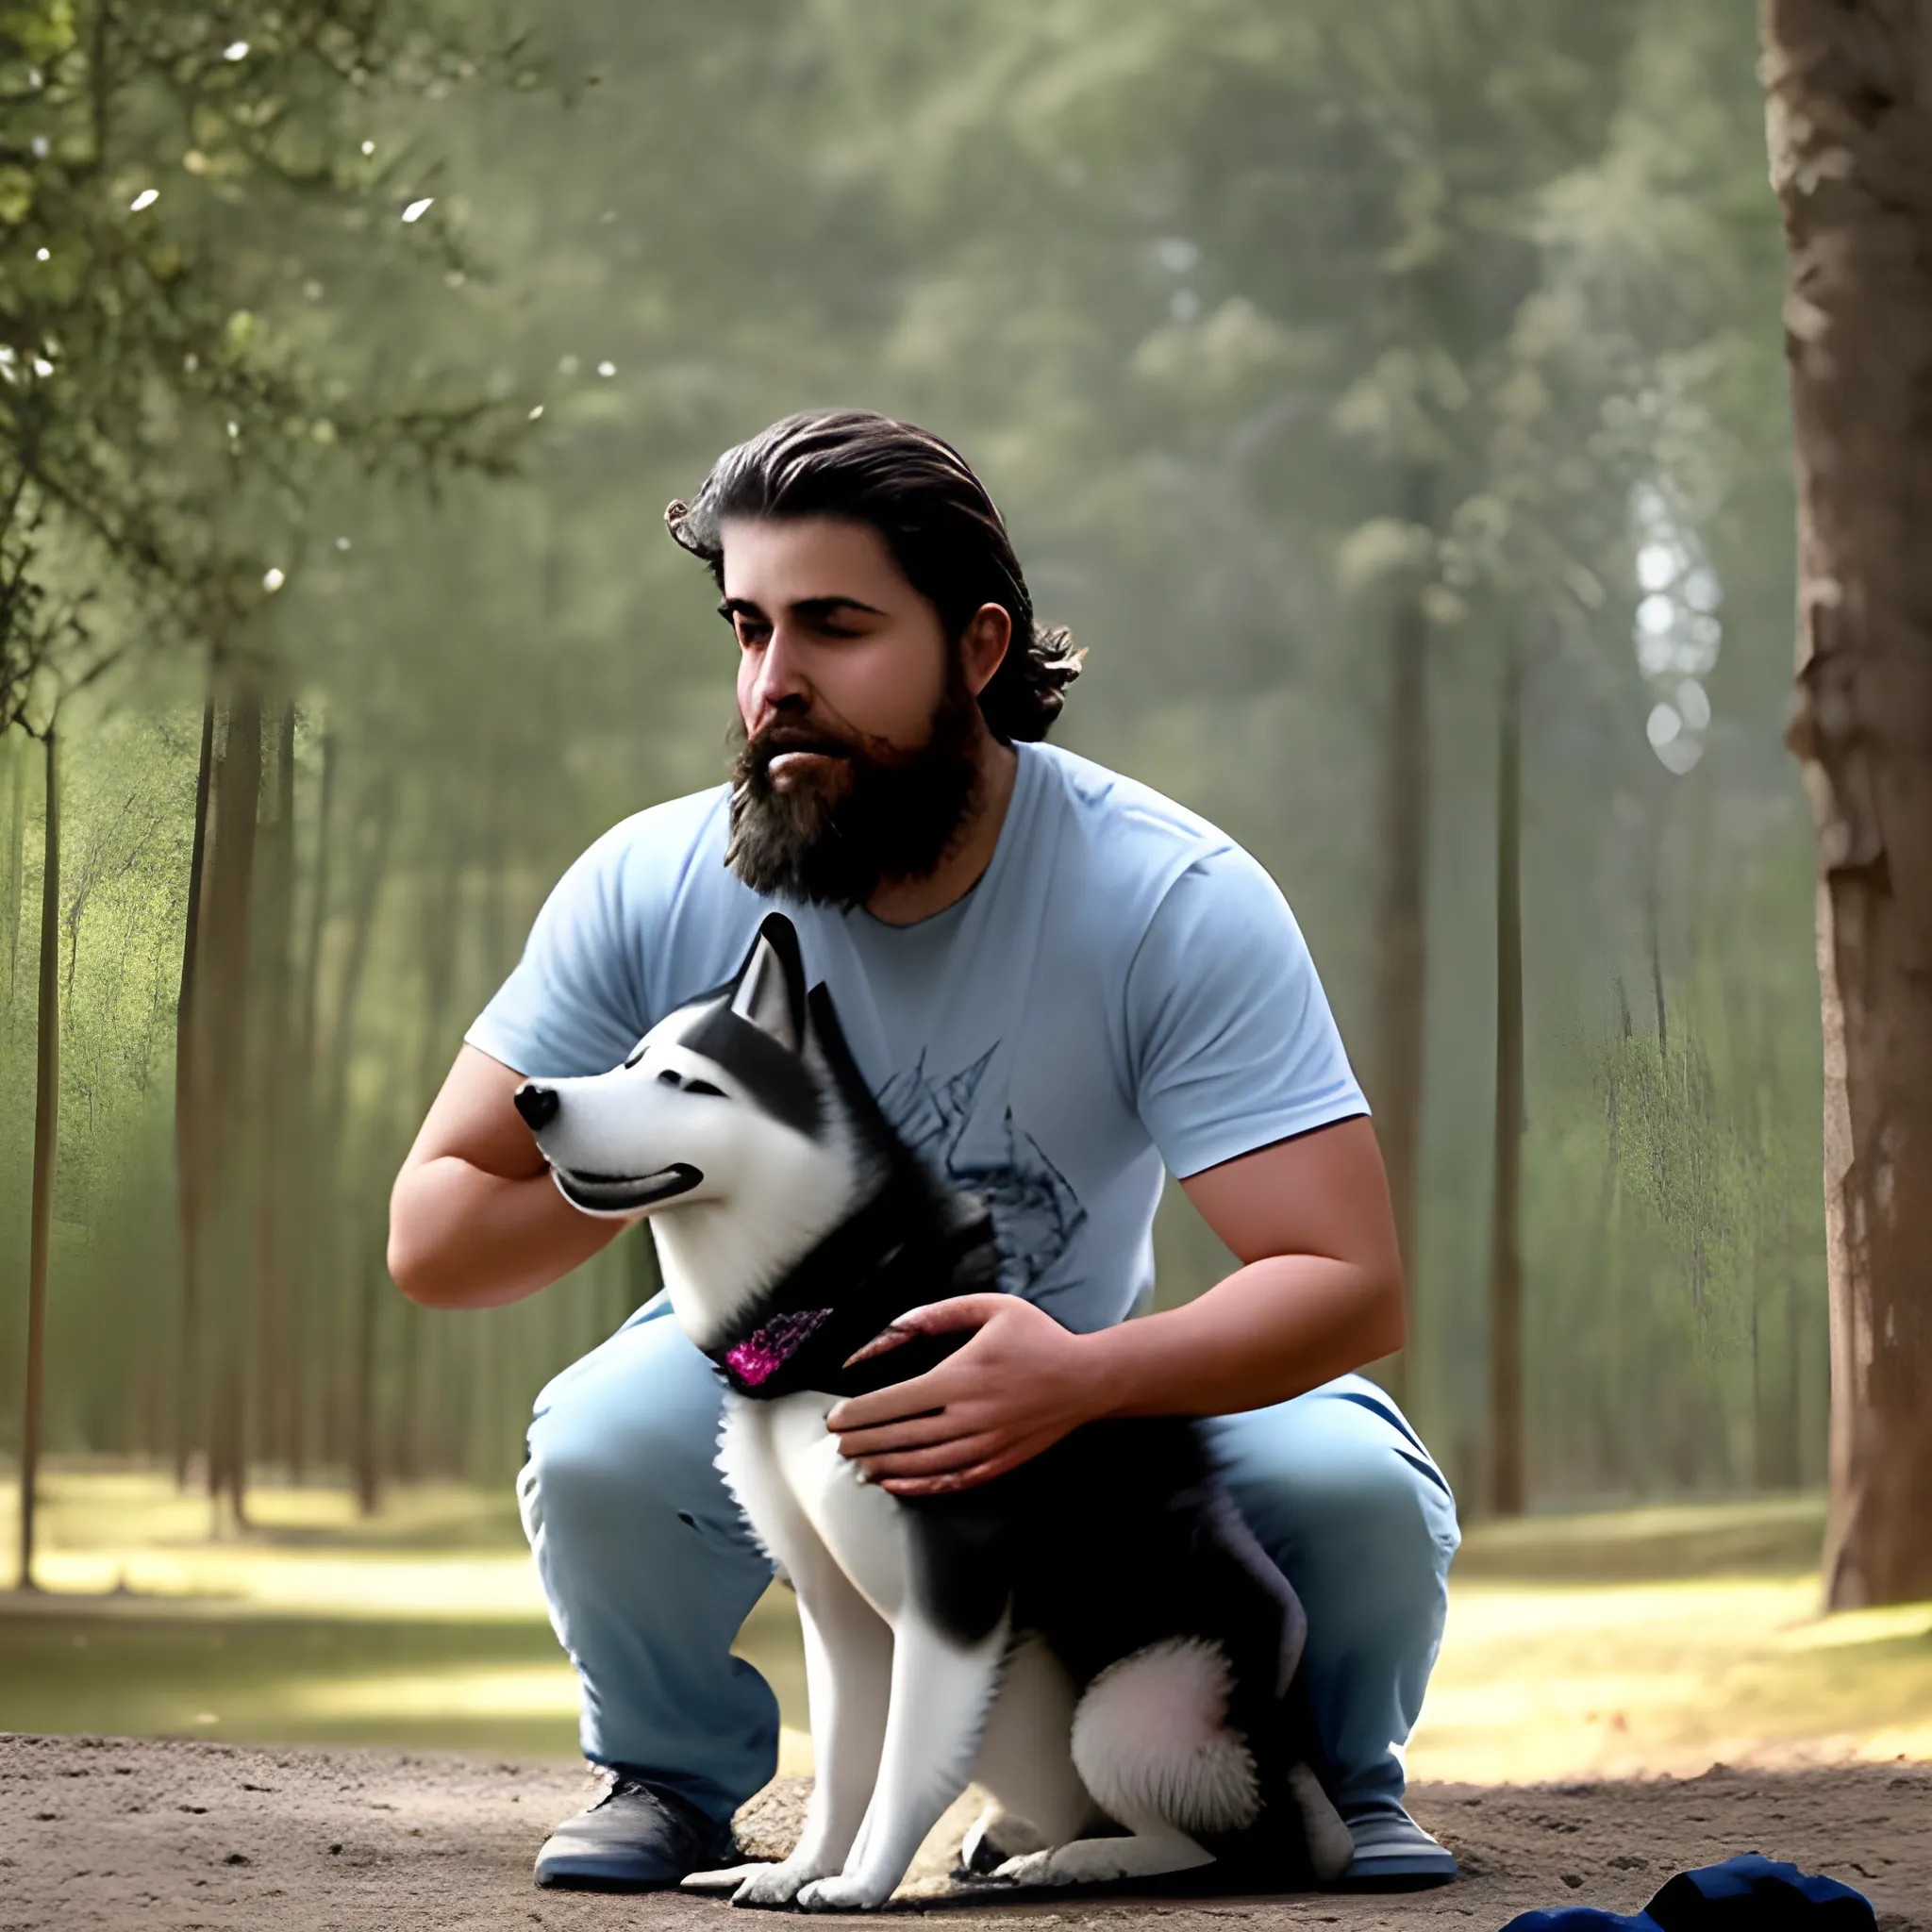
1080, 1254, 1403, 1416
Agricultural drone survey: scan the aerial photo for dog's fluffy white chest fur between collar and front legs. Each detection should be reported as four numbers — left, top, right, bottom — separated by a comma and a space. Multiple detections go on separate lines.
719, 1390, 907, 1623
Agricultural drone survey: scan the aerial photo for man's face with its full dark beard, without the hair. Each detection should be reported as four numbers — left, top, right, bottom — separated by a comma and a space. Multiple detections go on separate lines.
721, 518, 983, 907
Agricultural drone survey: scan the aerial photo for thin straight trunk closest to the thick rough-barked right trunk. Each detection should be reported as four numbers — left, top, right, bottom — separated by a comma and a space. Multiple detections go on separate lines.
1490, 645, 1524, 1517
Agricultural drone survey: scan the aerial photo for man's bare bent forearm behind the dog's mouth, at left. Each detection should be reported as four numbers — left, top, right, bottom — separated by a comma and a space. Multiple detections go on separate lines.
389, 1154, 628, 1307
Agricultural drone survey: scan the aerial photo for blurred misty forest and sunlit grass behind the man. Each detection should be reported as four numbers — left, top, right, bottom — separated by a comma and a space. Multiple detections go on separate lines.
0, 0, 1932, 1775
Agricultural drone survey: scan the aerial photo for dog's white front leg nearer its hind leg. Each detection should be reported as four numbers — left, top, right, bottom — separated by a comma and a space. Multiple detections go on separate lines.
798, 1602, 1008, 1913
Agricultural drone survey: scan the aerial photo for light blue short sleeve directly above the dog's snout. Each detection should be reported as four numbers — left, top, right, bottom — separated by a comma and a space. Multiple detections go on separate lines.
464, 821, 653, 1078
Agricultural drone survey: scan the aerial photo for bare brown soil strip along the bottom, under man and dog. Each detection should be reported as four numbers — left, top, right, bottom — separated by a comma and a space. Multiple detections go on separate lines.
0, 1737, 1932, 1932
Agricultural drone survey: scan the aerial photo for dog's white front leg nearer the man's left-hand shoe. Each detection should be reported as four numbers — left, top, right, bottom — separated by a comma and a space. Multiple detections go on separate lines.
684, 1549, 892, 1905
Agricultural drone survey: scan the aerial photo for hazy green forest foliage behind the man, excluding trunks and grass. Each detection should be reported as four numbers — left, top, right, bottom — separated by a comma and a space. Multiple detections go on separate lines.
0, 0, 1824, 1495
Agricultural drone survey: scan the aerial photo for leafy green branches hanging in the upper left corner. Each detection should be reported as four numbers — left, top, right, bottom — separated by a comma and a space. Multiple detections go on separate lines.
0, 0, 529, 730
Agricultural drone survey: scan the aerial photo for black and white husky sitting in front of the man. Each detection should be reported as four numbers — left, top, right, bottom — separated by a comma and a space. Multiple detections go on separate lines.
516, 914, 1353, 1910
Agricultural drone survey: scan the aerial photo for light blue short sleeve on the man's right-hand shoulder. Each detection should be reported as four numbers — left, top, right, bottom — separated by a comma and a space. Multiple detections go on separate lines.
1126, 846, 1368, 1178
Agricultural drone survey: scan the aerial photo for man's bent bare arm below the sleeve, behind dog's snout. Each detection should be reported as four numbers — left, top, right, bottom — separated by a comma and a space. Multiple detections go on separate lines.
389, 1047, 628, 1307
